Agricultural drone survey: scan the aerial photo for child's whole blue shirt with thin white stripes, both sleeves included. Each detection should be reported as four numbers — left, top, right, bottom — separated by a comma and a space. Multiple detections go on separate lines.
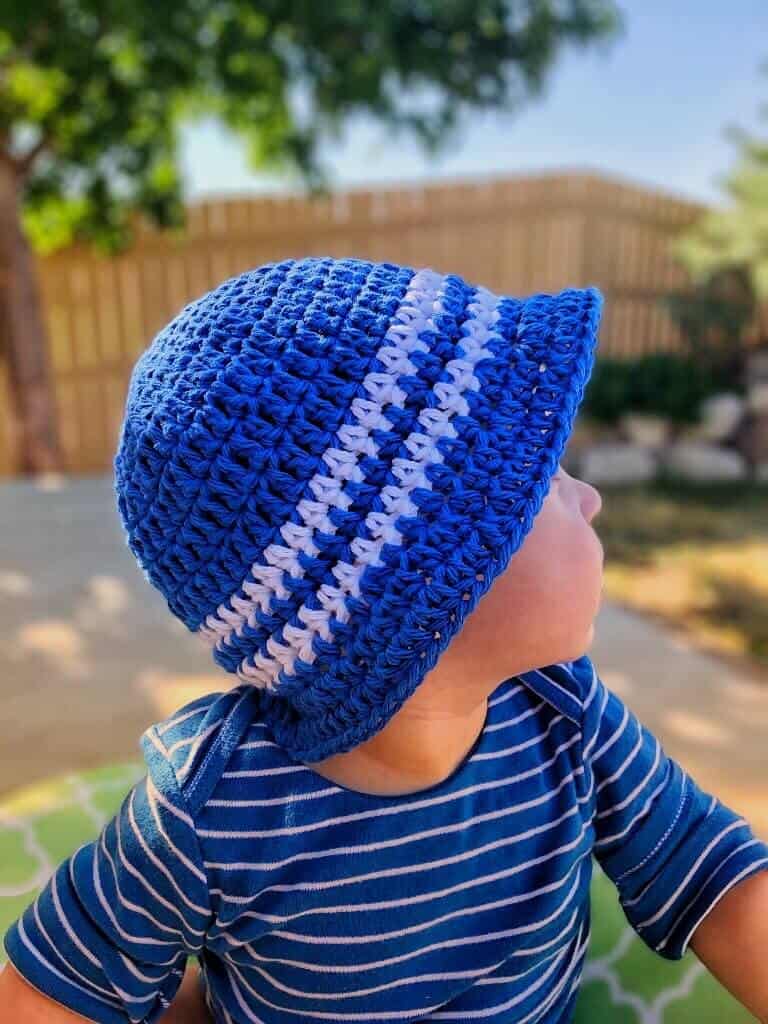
5, 655, 768, 1024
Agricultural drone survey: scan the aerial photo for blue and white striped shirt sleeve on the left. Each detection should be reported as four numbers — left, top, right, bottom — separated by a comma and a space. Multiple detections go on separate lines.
5, 727, 210, 1024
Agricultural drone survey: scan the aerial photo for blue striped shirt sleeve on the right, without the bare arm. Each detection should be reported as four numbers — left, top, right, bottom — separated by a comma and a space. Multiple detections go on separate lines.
571, 657, 768, 959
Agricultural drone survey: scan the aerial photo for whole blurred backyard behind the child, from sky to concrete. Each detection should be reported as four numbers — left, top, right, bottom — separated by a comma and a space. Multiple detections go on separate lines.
0, 0, 768, 847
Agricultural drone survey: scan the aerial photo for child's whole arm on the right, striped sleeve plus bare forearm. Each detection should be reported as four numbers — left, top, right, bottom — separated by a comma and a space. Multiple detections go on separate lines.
566, 656, 768, 1007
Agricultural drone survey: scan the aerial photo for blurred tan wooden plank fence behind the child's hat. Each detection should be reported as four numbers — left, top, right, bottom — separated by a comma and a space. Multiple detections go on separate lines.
0, 167, 753, 475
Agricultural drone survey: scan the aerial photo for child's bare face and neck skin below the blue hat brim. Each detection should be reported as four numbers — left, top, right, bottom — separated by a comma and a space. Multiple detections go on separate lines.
325, 467, 603, 787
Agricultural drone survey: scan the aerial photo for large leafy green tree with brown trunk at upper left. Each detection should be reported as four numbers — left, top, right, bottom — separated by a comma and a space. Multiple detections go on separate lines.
0, 0, 621, 472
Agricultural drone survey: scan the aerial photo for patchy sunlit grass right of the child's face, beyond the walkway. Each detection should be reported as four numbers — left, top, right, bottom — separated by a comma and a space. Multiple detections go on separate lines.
594, 481, 768, 669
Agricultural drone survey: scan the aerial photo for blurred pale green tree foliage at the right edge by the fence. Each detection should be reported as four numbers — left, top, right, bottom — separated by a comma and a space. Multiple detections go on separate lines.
674, 63, 768, 301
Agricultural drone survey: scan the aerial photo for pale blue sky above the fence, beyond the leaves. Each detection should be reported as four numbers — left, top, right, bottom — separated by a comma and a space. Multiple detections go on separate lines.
181, 0, 768, 205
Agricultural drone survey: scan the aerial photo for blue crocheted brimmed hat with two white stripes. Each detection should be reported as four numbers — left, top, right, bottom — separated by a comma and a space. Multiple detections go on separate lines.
115, 256, 602, 762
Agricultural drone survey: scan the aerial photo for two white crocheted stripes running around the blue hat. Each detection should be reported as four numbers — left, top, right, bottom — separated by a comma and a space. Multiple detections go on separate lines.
201, 269, 500, 688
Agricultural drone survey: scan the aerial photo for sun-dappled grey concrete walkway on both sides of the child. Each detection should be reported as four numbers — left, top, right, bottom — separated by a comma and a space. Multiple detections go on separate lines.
0, 476, 768, 839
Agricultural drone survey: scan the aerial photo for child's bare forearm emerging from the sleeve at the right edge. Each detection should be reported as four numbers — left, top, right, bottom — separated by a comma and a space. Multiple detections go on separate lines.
690, 870, 768, 1024
